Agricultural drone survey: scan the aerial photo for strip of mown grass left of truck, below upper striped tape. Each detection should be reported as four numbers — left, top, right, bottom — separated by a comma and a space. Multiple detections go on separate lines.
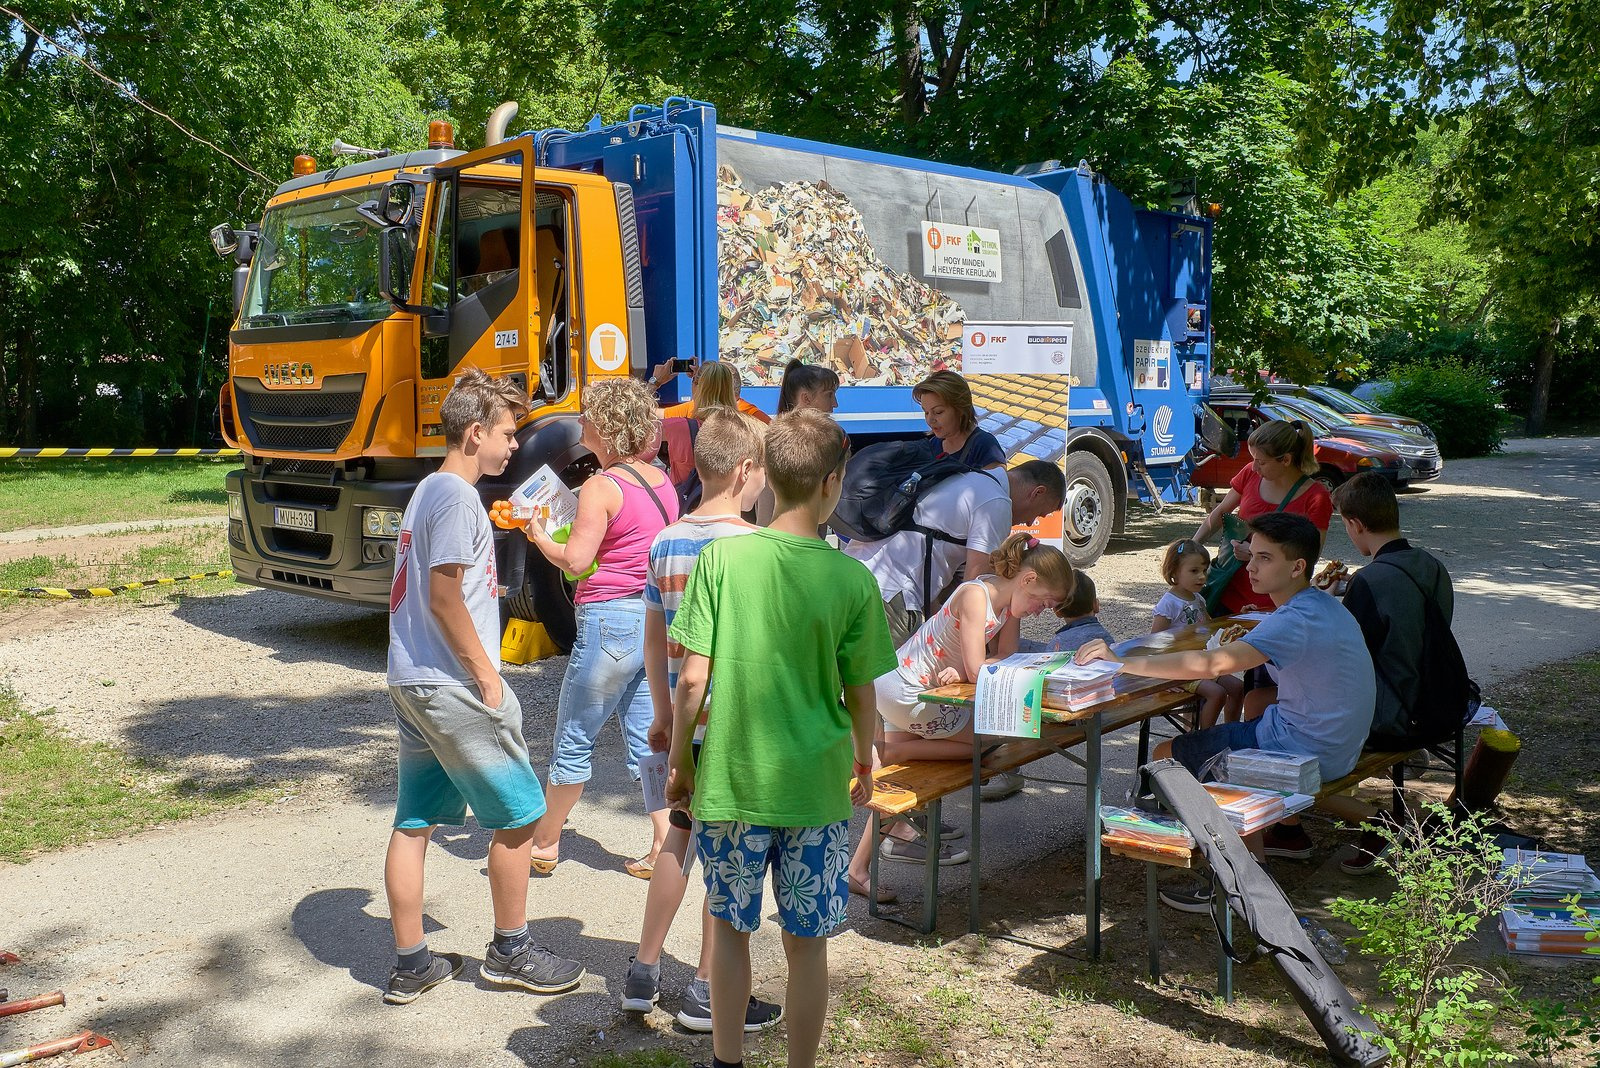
0, 459, 238, 531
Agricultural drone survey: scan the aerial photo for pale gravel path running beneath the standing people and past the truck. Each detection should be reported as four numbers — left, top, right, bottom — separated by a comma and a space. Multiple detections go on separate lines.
0, 440, 1600, 1065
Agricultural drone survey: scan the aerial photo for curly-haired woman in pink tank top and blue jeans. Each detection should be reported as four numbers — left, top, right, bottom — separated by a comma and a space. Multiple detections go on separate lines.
528, 379, 678, 878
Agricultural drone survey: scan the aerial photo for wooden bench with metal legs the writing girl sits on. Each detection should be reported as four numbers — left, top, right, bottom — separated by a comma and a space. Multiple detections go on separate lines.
867, 686, 1195, 934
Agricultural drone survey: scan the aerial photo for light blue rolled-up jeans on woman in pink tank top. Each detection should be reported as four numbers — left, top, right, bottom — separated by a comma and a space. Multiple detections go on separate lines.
549, 596, 654, 787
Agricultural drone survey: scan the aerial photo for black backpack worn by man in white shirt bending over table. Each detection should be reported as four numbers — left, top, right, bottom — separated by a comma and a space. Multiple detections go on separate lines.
829, 441, 974, 612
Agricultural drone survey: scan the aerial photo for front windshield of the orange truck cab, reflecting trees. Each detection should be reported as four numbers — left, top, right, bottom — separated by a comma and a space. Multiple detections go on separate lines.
238, 187, 394, 329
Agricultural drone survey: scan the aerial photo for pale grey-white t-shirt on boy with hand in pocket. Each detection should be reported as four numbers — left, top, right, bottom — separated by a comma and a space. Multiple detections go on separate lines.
389, 472, 499, 686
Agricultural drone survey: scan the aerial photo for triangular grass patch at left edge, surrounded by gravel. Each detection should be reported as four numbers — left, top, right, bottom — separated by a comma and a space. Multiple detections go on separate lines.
0, 692, 258, 863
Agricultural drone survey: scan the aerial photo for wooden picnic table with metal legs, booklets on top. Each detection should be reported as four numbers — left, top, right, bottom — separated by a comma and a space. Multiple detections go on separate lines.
908, 616, 1256, 959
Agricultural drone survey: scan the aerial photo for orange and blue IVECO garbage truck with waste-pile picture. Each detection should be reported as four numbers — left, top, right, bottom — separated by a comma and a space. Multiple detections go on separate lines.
211, 98, 1211, 646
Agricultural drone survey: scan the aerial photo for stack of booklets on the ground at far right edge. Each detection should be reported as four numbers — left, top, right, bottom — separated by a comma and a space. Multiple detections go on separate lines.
1499, 849, 1600, 956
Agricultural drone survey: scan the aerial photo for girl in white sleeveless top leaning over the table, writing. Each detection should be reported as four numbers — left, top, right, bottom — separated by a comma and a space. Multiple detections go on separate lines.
850, 534, 1077, 882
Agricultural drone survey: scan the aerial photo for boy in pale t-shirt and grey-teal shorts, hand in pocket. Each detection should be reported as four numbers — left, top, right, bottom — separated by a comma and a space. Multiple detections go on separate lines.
384, 369, 584, 1004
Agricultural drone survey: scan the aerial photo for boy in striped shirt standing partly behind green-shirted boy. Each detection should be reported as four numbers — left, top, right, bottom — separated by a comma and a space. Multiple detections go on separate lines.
622, 408, 782, 1034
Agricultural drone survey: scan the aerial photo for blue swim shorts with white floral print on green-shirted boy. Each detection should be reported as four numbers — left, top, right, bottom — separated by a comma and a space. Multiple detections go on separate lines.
694, 820, 850, 938
